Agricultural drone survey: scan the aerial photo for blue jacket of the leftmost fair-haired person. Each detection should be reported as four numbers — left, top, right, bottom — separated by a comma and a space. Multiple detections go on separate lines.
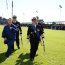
2, 24, 18, 40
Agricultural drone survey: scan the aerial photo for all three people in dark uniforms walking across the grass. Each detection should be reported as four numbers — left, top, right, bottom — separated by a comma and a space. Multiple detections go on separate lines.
2, 16, 44, 61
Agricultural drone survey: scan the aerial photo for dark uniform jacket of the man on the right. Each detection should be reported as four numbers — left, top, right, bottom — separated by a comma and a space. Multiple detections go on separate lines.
27, 24, 43, 40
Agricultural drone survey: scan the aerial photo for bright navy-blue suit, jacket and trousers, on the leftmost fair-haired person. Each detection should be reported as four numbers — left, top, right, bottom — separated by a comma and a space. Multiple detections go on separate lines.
2, 24, 18, 56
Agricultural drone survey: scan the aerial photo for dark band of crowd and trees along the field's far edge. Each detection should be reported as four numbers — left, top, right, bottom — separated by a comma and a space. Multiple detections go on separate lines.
0, 17, 65, 30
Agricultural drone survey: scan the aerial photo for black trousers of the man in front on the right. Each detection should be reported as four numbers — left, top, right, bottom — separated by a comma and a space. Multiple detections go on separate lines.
30, 40, 39, 59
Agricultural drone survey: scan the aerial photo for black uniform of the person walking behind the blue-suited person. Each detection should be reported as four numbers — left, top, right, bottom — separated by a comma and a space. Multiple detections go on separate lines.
13, 21, 22, 49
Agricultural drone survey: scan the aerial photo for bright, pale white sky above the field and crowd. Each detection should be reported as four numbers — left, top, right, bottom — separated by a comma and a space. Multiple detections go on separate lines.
0, 0, 65, 22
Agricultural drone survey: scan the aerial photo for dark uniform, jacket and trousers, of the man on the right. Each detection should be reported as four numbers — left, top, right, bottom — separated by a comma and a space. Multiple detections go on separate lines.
27, 24, 43, 59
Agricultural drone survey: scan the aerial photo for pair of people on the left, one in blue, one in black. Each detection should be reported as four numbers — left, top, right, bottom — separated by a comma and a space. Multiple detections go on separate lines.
2, 16, 22, 57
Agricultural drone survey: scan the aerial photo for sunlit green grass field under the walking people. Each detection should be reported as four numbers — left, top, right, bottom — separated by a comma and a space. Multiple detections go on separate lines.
0, 25, 65, 65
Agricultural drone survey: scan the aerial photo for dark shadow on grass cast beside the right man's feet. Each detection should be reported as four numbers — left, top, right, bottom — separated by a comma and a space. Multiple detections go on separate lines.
15, 53, 37, 65
